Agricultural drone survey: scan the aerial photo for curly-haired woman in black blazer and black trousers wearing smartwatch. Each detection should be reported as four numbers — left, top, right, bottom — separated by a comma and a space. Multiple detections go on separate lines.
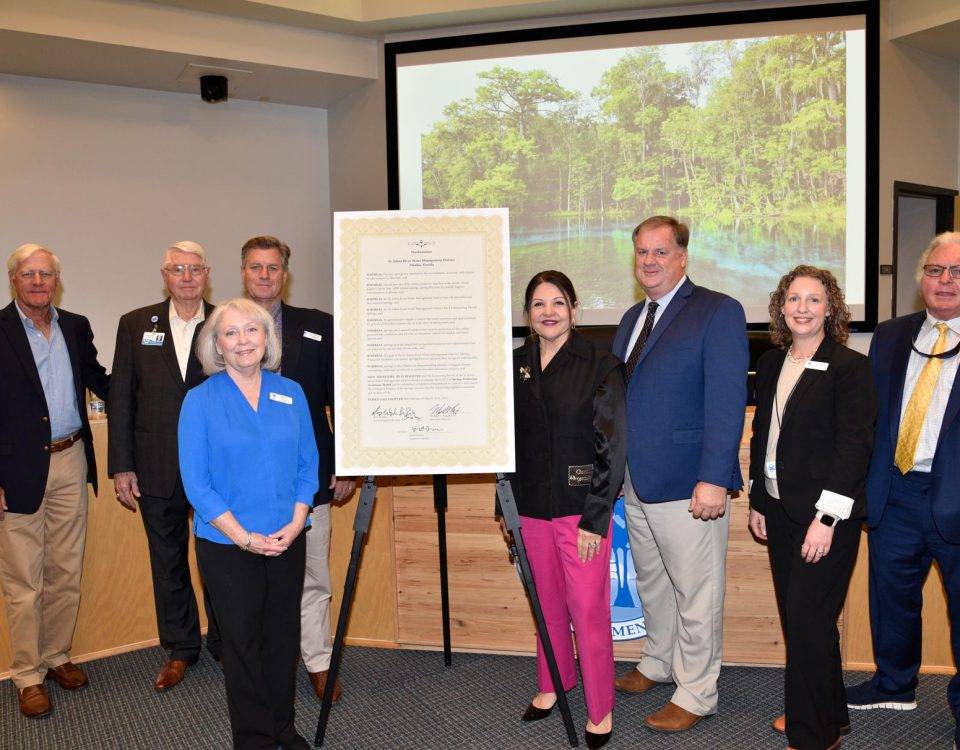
750, 266, 876, 750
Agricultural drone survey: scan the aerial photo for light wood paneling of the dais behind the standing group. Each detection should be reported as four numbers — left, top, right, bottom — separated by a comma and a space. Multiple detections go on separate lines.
0, 413, 954, 677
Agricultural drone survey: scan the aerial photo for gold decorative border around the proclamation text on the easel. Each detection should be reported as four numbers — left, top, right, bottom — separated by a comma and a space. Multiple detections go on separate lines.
336, 214, 513, 474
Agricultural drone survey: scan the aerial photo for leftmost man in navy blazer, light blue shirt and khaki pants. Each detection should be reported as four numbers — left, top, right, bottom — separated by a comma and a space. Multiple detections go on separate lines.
0, 244, 110, 718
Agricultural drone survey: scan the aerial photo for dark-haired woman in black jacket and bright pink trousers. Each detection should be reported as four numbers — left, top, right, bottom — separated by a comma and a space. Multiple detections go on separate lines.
510, 271, 627, 748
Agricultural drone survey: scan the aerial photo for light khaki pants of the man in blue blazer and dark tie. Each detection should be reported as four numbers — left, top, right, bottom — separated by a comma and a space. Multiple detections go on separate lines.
624, 476, 730, 716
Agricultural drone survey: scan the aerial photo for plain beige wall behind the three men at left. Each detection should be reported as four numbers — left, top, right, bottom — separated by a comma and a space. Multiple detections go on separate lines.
0, 75, 332, 369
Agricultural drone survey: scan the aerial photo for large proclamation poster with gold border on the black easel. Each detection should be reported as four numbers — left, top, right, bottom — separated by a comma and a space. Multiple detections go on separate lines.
333, 208, 514, 476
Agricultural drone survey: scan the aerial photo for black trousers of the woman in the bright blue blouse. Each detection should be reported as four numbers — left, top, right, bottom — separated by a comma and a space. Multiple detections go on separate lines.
197, 533, 309, 750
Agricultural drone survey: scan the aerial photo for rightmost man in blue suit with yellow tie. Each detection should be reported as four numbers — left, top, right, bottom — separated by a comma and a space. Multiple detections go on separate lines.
847, 232, 960, 743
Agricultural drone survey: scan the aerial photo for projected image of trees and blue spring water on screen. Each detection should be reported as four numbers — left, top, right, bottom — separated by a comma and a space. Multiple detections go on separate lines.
398, 32, 864, 322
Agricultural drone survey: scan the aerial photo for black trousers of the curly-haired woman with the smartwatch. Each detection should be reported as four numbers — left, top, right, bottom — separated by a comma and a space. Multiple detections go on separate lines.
766, 501, 861, 750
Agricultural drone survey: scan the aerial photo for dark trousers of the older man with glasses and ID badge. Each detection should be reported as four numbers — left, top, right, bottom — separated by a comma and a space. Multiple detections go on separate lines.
139, 478, 220, 664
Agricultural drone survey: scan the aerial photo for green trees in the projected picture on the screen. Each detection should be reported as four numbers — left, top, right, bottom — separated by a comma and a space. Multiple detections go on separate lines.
422, 33, 846, 222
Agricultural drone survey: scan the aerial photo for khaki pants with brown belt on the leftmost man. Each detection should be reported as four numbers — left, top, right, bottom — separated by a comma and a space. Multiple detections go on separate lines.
0, 440, 87, 688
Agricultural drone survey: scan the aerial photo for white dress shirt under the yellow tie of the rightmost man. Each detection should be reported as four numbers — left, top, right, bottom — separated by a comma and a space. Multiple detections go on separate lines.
900, 313, 960, 473
